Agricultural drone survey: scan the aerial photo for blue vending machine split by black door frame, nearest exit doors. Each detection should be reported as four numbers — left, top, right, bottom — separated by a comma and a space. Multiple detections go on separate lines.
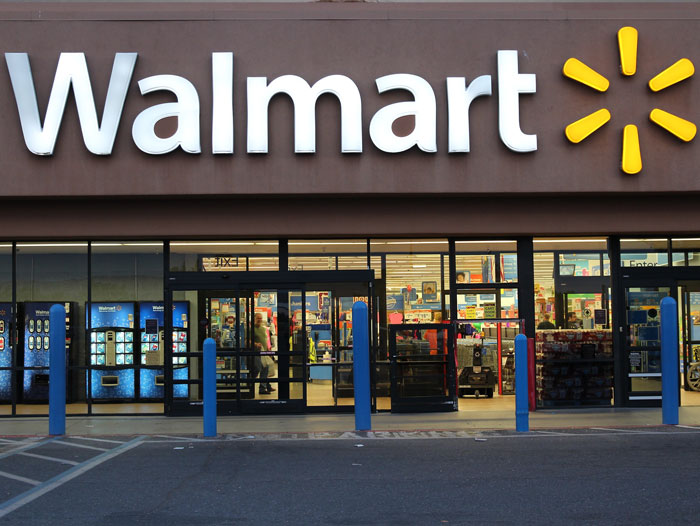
139, 301, 190, 399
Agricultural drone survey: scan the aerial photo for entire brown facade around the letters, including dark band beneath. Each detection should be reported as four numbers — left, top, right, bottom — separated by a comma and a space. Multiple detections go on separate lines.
0, 2, 700, 239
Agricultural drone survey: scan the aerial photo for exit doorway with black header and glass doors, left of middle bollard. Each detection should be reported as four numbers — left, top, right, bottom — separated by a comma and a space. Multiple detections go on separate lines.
165, 271, 372, 415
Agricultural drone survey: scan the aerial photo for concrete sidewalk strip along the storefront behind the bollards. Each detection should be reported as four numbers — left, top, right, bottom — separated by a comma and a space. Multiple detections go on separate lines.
0, 407, 700, 437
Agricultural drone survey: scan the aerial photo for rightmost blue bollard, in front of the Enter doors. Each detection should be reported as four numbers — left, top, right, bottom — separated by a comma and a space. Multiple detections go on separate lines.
661, 296, 679, 426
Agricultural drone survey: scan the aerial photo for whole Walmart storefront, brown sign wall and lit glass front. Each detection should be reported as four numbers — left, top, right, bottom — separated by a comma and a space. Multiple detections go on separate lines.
0, 3, 700, 415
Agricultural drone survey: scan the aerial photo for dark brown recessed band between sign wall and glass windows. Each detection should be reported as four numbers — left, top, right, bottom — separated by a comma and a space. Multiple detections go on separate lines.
0, 195, 700, 240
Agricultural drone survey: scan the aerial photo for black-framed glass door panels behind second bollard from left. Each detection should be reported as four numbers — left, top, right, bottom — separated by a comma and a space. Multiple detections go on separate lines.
166, 286, 306, 414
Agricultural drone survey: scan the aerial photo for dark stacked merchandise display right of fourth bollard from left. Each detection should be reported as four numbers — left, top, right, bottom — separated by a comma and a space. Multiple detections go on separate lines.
535, 330, 614, 407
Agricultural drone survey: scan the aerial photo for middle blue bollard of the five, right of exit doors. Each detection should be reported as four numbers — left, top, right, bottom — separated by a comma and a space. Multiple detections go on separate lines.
352, 301, 372, 431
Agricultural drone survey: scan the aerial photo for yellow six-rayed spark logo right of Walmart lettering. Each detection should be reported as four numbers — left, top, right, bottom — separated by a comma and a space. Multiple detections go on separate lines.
563, 27, 697, 174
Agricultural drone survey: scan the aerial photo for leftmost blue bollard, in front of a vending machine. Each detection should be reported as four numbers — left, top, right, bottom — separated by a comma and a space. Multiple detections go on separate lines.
49, 304, 66, 435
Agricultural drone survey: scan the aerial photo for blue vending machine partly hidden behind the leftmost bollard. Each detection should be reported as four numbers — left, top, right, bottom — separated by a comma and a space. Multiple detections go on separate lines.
21, 301, 75, 402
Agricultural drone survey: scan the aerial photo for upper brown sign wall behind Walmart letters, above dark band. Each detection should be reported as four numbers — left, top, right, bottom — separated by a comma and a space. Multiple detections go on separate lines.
0, 3, 700, 202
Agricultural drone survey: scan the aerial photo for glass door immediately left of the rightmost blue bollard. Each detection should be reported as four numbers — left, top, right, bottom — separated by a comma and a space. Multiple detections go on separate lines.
623, 281, 675, 406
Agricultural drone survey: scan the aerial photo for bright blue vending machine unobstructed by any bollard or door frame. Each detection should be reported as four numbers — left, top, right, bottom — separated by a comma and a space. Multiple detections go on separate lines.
87, 302, 136, 401
